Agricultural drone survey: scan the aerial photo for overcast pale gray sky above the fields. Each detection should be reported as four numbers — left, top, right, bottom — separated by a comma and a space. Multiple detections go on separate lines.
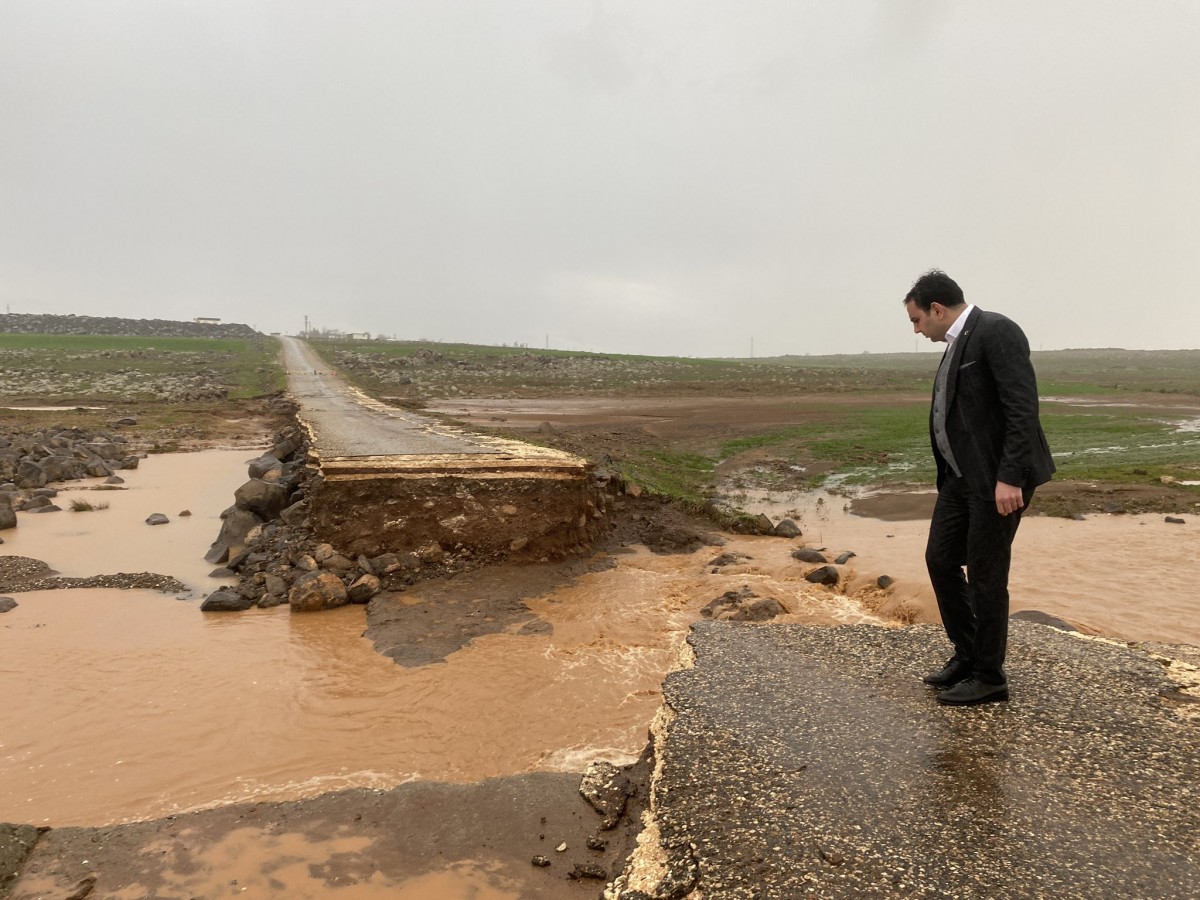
0, 0, 1200, 356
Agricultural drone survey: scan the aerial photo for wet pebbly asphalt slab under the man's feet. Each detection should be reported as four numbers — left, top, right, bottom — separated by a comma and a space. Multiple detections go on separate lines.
623, 622, 1200, 898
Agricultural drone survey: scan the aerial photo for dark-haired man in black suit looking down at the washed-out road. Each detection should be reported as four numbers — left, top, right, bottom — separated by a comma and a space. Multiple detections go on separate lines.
905, 270, 1055, 706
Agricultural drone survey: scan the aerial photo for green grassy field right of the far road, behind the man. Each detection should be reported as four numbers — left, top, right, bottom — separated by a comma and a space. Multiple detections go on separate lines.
313, 341, 1200, 505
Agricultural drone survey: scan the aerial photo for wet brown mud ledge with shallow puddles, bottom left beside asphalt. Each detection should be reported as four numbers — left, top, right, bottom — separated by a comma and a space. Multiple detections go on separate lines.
7, 762, 646, 900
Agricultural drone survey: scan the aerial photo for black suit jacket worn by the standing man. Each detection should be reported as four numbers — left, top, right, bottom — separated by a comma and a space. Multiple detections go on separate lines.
929, 307, 1055, 497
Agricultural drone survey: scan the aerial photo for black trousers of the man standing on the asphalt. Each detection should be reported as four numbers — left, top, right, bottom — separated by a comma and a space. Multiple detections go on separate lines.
925, 475, 1033, 684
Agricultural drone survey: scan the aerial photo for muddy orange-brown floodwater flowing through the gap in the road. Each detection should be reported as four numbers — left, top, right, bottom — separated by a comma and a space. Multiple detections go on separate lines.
0, 450, 1200, 826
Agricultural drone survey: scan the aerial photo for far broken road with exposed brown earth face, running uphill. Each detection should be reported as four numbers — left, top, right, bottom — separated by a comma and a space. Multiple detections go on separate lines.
281, 337, 605, 559
